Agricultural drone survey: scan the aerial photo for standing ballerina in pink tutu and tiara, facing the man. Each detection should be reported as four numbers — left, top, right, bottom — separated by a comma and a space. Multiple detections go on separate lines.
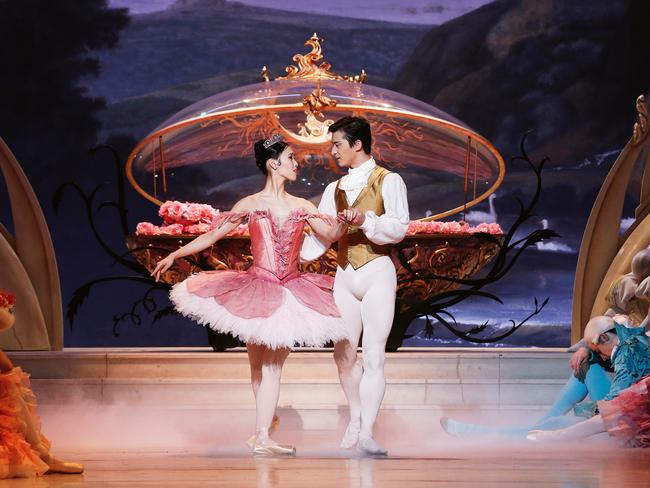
152, 135, 347, 455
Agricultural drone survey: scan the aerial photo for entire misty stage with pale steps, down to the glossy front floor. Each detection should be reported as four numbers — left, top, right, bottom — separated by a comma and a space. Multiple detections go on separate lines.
0, 349, 650, 488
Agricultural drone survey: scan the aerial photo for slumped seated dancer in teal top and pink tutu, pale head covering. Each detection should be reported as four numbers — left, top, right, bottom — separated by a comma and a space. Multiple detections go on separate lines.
527, 315, 650, 447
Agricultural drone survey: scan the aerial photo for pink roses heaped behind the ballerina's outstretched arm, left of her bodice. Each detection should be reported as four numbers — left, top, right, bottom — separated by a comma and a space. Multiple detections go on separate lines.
135, 201, 248, 236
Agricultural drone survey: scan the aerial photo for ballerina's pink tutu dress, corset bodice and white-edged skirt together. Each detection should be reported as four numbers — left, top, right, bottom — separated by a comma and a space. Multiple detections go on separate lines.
170, 211, 347, 349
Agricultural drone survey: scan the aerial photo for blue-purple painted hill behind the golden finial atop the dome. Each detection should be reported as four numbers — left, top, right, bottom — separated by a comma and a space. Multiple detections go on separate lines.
87, 0, 429, 103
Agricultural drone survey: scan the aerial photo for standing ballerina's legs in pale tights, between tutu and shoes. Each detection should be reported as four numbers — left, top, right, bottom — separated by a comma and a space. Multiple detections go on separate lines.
246, 344, 289, 437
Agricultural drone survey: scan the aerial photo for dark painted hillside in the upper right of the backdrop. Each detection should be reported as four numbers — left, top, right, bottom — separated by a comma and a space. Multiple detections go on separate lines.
393, 0, 650, 164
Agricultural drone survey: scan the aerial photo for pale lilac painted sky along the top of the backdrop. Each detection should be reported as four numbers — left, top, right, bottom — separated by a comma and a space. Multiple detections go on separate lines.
109, 0, 492, 25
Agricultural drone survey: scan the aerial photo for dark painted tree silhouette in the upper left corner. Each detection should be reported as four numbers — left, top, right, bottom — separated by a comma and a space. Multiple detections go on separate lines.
0, 0, 129, 188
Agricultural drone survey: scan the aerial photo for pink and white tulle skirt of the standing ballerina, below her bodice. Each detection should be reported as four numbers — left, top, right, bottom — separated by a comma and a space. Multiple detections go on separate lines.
170, 267, 347, 349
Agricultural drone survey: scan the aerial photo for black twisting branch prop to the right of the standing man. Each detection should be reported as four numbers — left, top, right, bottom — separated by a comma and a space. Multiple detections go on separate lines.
387, 132, 559, 350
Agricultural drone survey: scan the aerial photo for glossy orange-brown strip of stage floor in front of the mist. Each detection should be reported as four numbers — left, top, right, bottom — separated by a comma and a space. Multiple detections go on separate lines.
5, 446, 650, 488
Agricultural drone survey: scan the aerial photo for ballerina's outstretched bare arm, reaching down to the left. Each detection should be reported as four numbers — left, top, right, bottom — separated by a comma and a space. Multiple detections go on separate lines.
151, 199, 249, 281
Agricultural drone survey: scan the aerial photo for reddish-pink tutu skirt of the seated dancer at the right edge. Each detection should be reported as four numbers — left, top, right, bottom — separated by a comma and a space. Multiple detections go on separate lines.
598, 375, 650, 447
